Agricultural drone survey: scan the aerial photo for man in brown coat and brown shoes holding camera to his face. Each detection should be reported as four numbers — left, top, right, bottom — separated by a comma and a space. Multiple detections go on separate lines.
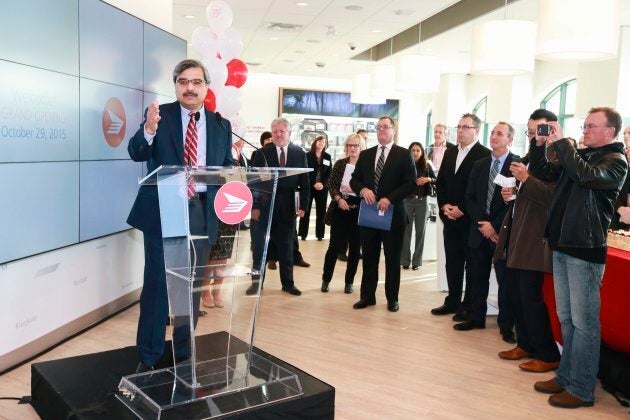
495, 109, 560, 373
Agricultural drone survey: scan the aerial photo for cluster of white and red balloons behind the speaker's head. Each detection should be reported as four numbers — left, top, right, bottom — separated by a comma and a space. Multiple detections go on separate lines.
192, 0, 247, 136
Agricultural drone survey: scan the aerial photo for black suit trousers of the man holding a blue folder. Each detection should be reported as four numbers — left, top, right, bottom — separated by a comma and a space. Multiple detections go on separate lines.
359, 225, 405, 303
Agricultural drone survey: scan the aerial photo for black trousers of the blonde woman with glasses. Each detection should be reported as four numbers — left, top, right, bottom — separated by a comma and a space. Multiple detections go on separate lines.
322, 208, 361, 284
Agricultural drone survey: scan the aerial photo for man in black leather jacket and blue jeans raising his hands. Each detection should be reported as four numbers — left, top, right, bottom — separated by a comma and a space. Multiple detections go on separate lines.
530, 107, 628, 408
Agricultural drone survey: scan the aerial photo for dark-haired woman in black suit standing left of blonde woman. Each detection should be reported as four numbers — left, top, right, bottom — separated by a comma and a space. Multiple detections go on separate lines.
298, 136, 331, 241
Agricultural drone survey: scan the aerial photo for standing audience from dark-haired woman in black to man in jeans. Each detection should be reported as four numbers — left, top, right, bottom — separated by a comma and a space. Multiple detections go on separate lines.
249, 107, 630, 408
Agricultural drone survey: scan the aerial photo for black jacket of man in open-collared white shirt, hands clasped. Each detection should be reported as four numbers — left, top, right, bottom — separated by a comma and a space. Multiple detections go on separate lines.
436, 142, 490, 238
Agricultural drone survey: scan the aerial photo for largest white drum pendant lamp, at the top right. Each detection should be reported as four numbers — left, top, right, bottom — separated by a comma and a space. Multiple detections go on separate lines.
536, 0, 621, 61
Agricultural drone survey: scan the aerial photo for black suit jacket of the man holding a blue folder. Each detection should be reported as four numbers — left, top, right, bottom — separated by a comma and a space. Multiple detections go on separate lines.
350, 144, 416, 226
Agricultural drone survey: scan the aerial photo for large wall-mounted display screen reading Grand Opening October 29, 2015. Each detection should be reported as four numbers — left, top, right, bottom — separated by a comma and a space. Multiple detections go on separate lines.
0, 0, 186, 264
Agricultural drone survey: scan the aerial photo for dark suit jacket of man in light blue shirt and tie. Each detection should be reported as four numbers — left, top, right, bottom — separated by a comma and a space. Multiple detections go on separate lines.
465, 152, 517, 248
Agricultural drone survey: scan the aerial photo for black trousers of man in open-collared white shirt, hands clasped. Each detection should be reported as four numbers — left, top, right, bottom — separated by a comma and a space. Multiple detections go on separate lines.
444, 233, 470, 312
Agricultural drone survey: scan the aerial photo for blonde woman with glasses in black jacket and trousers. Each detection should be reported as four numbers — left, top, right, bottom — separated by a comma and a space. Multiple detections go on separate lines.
321, 134, 361, 293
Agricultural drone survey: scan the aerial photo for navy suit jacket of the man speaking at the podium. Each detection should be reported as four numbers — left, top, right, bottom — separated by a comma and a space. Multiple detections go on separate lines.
127, 102, 234, 235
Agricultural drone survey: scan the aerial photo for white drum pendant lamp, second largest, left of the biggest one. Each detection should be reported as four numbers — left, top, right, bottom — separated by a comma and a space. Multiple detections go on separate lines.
470, 0, 536, 76
